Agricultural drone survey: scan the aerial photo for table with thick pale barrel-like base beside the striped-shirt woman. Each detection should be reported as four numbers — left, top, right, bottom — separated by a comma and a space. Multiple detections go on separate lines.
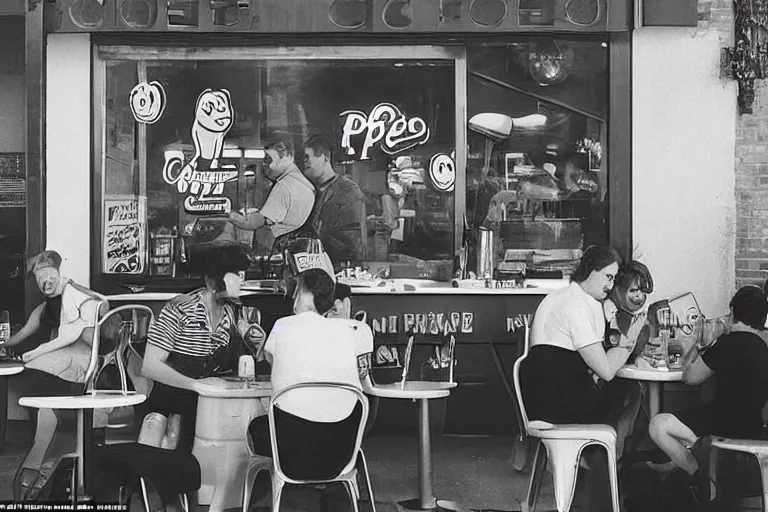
192, 378, 272, 512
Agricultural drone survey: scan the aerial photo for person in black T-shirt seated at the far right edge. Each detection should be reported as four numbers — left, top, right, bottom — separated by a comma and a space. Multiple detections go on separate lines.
649, 286, 768, 501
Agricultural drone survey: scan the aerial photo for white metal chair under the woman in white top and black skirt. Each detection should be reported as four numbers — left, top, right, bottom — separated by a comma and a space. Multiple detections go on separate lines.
513, 319, 620, 512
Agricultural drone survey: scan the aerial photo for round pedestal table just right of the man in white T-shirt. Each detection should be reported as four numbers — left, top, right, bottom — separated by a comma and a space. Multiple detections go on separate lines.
364, 381, 461, 511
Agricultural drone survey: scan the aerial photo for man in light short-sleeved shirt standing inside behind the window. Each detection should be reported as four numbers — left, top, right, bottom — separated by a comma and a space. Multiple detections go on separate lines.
229, 140, 315, 253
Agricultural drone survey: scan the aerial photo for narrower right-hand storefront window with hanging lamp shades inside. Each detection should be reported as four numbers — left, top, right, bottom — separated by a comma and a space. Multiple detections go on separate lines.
466, 36, 610, 277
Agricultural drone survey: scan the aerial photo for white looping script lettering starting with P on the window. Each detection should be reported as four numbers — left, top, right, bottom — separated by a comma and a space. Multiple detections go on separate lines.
339, 103, 430, 160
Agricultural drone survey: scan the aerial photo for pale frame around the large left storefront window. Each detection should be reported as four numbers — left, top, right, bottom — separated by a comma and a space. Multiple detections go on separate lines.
91, 43, 468, 290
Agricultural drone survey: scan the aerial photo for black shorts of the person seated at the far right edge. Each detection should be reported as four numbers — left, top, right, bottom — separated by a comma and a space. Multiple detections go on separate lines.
673, 404, 763, 439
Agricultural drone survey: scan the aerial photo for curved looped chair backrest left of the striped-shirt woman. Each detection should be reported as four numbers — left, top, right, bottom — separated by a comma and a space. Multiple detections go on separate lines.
85, 304, 155, 394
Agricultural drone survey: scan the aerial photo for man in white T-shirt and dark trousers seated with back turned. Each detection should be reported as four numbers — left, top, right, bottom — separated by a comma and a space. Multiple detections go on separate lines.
249, 254, 373, 478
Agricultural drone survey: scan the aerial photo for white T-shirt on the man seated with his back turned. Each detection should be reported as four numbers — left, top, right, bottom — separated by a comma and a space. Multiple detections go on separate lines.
264, 312, 373, 422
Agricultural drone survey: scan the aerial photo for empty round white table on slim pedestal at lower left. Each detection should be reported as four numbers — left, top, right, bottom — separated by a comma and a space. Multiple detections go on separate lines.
19, 390, 147, 499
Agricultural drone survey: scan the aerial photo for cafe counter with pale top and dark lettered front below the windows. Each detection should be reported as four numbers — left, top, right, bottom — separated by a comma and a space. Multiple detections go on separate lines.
108, 279, 567, 435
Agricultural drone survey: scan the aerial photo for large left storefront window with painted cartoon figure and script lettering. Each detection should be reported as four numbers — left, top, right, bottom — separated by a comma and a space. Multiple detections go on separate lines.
95, 47, 463, 279
